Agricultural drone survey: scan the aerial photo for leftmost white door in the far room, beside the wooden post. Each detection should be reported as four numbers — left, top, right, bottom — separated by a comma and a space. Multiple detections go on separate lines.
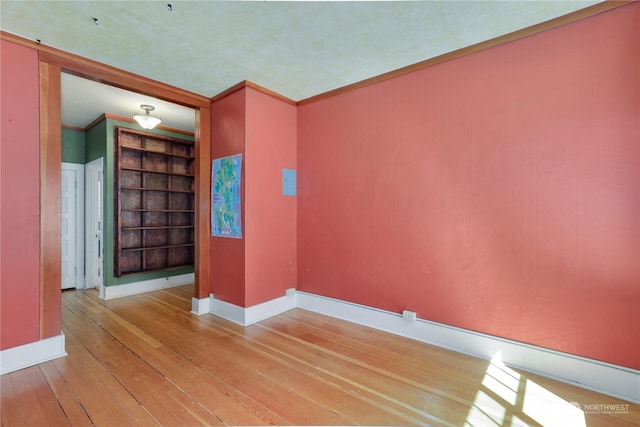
60, 163, 84, 289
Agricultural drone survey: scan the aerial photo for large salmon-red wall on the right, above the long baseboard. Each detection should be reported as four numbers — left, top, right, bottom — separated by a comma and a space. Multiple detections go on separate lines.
298, 3, 640, 369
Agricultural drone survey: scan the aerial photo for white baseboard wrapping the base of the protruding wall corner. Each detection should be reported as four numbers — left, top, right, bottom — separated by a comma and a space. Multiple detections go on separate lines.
204, 292, 297, 326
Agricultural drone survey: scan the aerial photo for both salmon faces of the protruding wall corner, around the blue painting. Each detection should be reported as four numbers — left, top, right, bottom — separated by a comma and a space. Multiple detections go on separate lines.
211, 87, 297, 307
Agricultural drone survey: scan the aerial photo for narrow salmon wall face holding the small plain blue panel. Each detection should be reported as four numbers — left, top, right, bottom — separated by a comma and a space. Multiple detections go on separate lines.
245, 88, 298, 307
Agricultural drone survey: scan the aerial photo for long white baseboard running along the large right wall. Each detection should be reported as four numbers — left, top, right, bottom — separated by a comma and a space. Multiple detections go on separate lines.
297, 292, 640, 403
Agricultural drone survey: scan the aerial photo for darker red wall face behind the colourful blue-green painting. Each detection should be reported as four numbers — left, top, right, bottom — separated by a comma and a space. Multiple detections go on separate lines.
211, 89, 246, 307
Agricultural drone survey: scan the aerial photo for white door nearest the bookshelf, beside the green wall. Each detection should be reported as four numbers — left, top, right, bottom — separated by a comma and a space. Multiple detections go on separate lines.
85, 158, 104, 290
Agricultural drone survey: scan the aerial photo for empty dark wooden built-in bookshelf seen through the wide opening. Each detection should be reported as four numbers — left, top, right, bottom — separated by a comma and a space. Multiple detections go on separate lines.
115, 127, 195, 277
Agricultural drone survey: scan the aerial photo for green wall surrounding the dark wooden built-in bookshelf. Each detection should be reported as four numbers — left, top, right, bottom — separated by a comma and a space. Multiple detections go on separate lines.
85, 118, 194, 286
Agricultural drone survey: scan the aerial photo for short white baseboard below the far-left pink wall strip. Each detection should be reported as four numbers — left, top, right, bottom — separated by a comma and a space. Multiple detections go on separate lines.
0, 334, 67, 375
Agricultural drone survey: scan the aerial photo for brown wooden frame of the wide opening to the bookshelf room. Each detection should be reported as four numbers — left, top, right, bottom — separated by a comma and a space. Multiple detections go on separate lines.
24, 33, 211, 339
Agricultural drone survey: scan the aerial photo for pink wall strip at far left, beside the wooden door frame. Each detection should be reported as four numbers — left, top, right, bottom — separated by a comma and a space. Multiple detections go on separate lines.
0, 40, 40, 349
